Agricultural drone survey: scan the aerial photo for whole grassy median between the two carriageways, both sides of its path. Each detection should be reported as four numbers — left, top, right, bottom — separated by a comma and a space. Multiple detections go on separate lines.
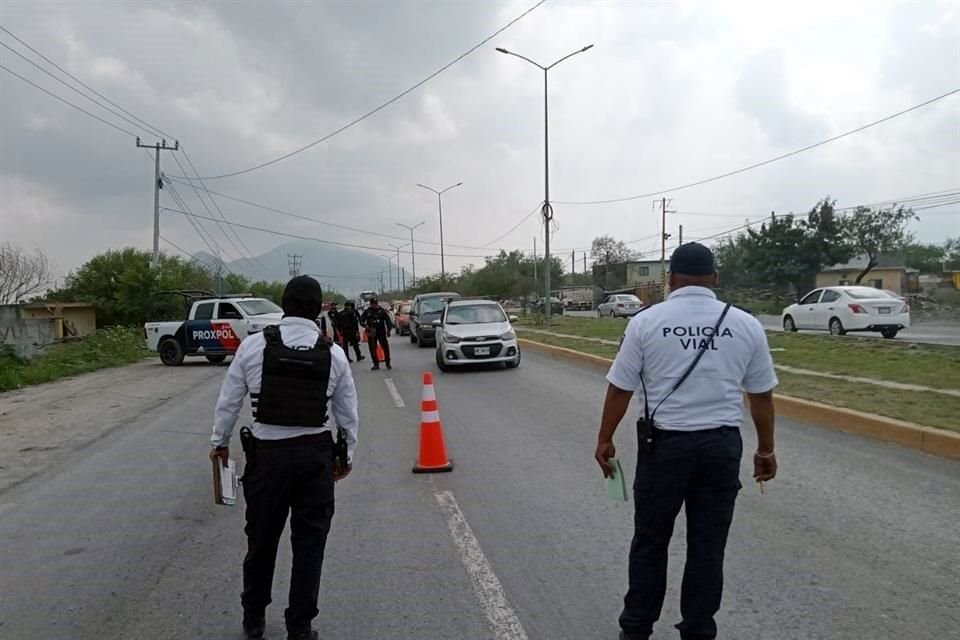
516, 318, 960, 431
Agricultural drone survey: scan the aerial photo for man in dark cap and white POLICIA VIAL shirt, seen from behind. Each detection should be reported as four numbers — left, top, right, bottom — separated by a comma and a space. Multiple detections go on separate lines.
595, 243, 778, 640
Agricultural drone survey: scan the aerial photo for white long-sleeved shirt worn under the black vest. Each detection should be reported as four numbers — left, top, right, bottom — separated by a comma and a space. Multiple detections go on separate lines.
210, 317, 360, 461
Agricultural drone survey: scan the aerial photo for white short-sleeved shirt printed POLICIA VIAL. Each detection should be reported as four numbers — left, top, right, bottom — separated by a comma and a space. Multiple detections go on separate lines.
607, 287, 778, 431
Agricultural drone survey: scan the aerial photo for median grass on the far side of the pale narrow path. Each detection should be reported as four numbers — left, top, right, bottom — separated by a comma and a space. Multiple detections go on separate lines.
516, 318, 960, 390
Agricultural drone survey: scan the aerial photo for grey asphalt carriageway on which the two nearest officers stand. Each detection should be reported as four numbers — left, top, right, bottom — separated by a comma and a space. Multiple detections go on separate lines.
0, 338, 960, 640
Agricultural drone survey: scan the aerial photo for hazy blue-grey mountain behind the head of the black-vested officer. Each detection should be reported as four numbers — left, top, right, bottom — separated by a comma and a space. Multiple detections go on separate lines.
193, 240, 411, 296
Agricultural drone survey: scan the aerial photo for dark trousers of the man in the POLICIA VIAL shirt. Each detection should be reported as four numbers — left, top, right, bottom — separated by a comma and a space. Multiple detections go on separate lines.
620, 427, 743, 640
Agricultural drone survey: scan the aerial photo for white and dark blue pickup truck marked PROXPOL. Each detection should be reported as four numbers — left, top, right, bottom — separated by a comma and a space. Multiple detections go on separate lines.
143, 292, 283, 366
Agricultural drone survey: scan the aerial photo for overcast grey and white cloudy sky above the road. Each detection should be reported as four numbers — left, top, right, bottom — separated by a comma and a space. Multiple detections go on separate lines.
0, 0, 960, 282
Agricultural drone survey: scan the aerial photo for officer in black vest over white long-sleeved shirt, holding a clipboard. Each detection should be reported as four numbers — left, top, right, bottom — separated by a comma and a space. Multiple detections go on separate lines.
210, 276, 358, 640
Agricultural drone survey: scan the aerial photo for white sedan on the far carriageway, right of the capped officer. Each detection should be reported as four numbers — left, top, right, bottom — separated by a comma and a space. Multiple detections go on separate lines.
781, 286, 910, 339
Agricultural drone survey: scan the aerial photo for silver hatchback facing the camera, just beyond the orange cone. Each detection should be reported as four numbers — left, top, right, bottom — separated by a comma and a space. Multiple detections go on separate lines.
432, 300, 521, 371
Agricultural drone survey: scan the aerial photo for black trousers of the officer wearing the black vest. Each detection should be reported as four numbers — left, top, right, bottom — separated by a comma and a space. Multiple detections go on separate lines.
241, 433, 334, 631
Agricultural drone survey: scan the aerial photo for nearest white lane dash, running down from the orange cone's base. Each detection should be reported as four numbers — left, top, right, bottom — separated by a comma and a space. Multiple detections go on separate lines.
433, 491, 527, 640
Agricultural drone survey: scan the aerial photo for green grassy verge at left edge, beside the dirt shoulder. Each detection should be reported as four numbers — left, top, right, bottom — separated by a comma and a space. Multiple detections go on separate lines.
0, 327, 147, 391
